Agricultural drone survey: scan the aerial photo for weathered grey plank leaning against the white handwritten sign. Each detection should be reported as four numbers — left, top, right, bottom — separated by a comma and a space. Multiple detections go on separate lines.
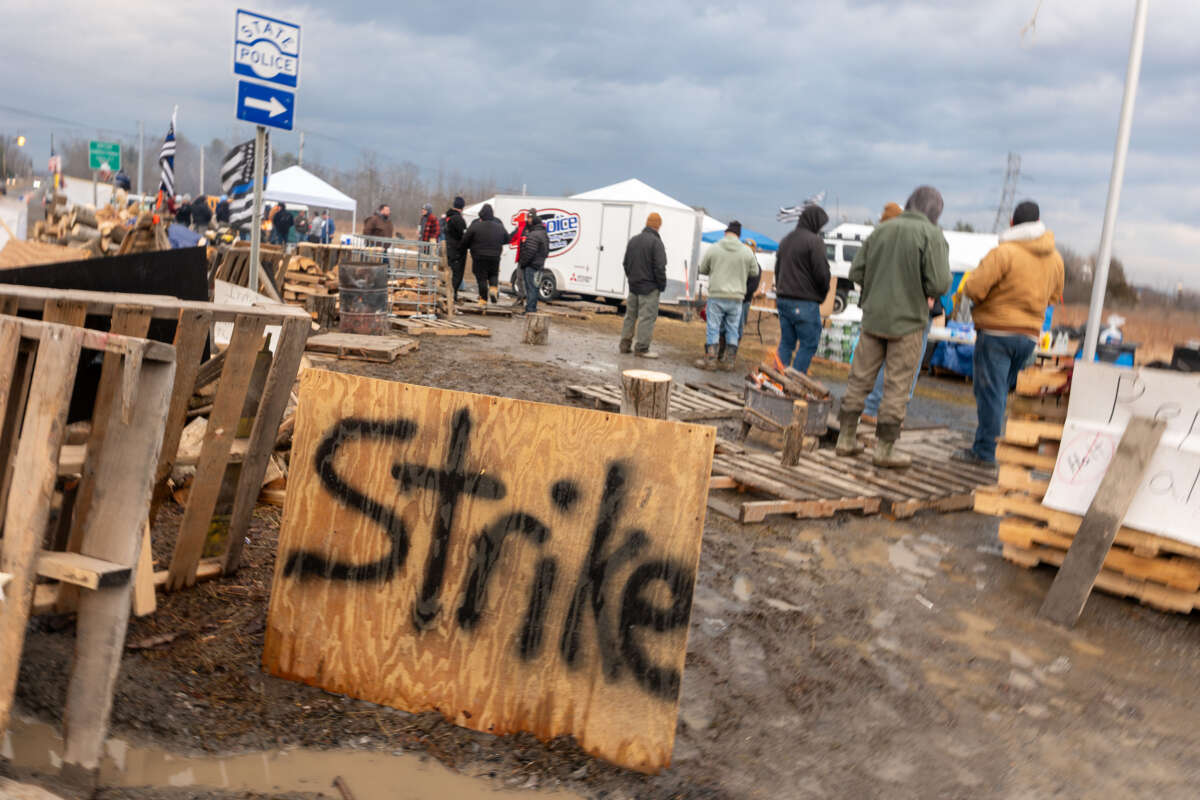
1038, 416, 1166, 627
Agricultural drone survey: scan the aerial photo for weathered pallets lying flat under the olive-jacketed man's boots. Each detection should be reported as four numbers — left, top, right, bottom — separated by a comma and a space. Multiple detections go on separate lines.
709, 428, 995, 522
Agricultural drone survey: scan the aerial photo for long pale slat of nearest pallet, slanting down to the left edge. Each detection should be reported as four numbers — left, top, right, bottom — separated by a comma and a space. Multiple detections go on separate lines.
0, 320, 83, 730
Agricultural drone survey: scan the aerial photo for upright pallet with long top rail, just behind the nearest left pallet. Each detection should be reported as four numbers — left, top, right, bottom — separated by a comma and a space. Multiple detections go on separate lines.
0, 285, 312, 590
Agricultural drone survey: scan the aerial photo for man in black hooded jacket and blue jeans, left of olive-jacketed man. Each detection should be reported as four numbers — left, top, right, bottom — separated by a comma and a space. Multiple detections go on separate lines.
775, 204, 829, 373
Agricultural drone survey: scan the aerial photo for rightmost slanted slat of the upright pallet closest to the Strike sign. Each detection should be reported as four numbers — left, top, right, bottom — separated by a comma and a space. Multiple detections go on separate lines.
222, 319, 308, 573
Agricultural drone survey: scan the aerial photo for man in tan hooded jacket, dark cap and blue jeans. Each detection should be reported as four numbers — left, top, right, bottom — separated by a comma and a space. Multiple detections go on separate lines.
953, 200, 1063, 465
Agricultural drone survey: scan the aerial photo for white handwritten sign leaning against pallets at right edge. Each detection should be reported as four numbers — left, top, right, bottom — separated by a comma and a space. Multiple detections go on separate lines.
1043, 361, 1200, 546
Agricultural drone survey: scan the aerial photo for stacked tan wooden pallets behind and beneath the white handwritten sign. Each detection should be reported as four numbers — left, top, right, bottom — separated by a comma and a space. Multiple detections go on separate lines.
974, 388, 1200, 613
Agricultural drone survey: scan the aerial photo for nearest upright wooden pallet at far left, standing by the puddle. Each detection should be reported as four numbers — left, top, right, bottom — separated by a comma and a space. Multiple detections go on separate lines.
0, 317, 175, 776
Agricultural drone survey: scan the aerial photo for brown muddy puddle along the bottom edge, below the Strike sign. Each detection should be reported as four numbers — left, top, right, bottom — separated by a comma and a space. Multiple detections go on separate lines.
0, 715, 580, 800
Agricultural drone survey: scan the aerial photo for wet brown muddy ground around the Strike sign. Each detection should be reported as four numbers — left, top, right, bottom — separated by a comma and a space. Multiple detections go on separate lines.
9, 315, 1200, 800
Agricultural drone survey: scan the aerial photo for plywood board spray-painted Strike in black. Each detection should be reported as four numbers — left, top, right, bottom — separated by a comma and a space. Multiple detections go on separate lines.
264, 369, 715, 771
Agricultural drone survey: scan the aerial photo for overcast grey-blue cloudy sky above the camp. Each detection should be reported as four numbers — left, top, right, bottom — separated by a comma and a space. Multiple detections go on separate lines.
0, 0, 1200, 287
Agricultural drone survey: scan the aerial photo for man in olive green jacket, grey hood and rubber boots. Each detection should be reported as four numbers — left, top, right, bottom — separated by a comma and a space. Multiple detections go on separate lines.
838, 186, 950, 468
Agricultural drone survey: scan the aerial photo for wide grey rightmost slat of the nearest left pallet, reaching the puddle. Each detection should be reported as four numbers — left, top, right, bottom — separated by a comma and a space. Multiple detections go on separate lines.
62, 352, 175, 774
